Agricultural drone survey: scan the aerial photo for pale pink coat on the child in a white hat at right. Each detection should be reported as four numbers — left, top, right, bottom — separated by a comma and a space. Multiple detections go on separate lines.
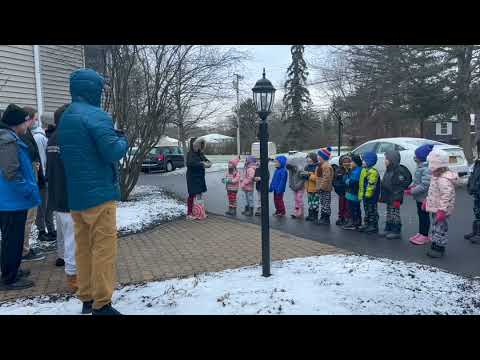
426, 171, 458, 215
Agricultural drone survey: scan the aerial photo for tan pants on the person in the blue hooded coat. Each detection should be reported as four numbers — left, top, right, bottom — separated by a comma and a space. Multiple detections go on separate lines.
72, 201, 117, 309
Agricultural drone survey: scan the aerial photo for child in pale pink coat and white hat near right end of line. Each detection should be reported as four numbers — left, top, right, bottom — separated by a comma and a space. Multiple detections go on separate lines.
423, 150, 458, 258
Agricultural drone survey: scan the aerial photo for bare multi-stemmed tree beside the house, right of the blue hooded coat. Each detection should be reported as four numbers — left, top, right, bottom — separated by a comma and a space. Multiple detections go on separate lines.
100, 45, 185, 201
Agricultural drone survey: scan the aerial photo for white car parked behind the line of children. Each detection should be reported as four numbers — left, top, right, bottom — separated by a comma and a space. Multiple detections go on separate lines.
331, 137, 469, 176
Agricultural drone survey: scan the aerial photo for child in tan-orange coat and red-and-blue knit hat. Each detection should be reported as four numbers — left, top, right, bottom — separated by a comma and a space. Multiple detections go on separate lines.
316, 147, 333, 225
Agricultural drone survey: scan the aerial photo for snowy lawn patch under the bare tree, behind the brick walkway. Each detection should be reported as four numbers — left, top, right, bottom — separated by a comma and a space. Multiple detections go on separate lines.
15, 186, 187, 250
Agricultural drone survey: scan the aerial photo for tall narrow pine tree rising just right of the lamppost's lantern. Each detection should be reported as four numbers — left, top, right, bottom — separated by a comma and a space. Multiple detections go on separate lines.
283, 45, 311, 150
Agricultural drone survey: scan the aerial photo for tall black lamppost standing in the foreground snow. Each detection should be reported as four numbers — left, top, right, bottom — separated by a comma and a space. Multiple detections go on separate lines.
252, 69, 275, 277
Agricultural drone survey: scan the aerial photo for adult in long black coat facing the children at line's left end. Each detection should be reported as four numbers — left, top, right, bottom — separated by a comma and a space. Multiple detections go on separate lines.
186, 137, 212, 220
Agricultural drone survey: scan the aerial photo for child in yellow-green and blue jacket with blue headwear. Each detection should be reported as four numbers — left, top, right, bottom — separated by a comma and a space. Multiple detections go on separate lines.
358, 152, 380, 234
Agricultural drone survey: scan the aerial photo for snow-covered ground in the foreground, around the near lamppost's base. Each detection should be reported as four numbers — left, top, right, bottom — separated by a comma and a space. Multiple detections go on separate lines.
0, 255, 480, 315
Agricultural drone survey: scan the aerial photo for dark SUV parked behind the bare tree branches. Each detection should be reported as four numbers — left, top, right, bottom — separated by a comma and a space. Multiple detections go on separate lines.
142, 146, 185, 174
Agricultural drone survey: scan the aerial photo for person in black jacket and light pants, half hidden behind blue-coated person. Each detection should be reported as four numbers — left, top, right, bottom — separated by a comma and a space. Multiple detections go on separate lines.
47, 104, 78, 291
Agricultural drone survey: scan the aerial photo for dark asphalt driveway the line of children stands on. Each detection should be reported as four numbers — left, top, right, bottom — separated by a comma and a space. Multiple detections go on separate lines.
139, 168, 480, 276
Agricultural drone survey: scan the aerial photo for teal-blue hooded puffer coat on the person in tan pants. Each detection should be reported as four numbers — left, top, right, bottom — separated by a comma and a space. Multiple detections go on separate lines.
58, 69, 128, 211
